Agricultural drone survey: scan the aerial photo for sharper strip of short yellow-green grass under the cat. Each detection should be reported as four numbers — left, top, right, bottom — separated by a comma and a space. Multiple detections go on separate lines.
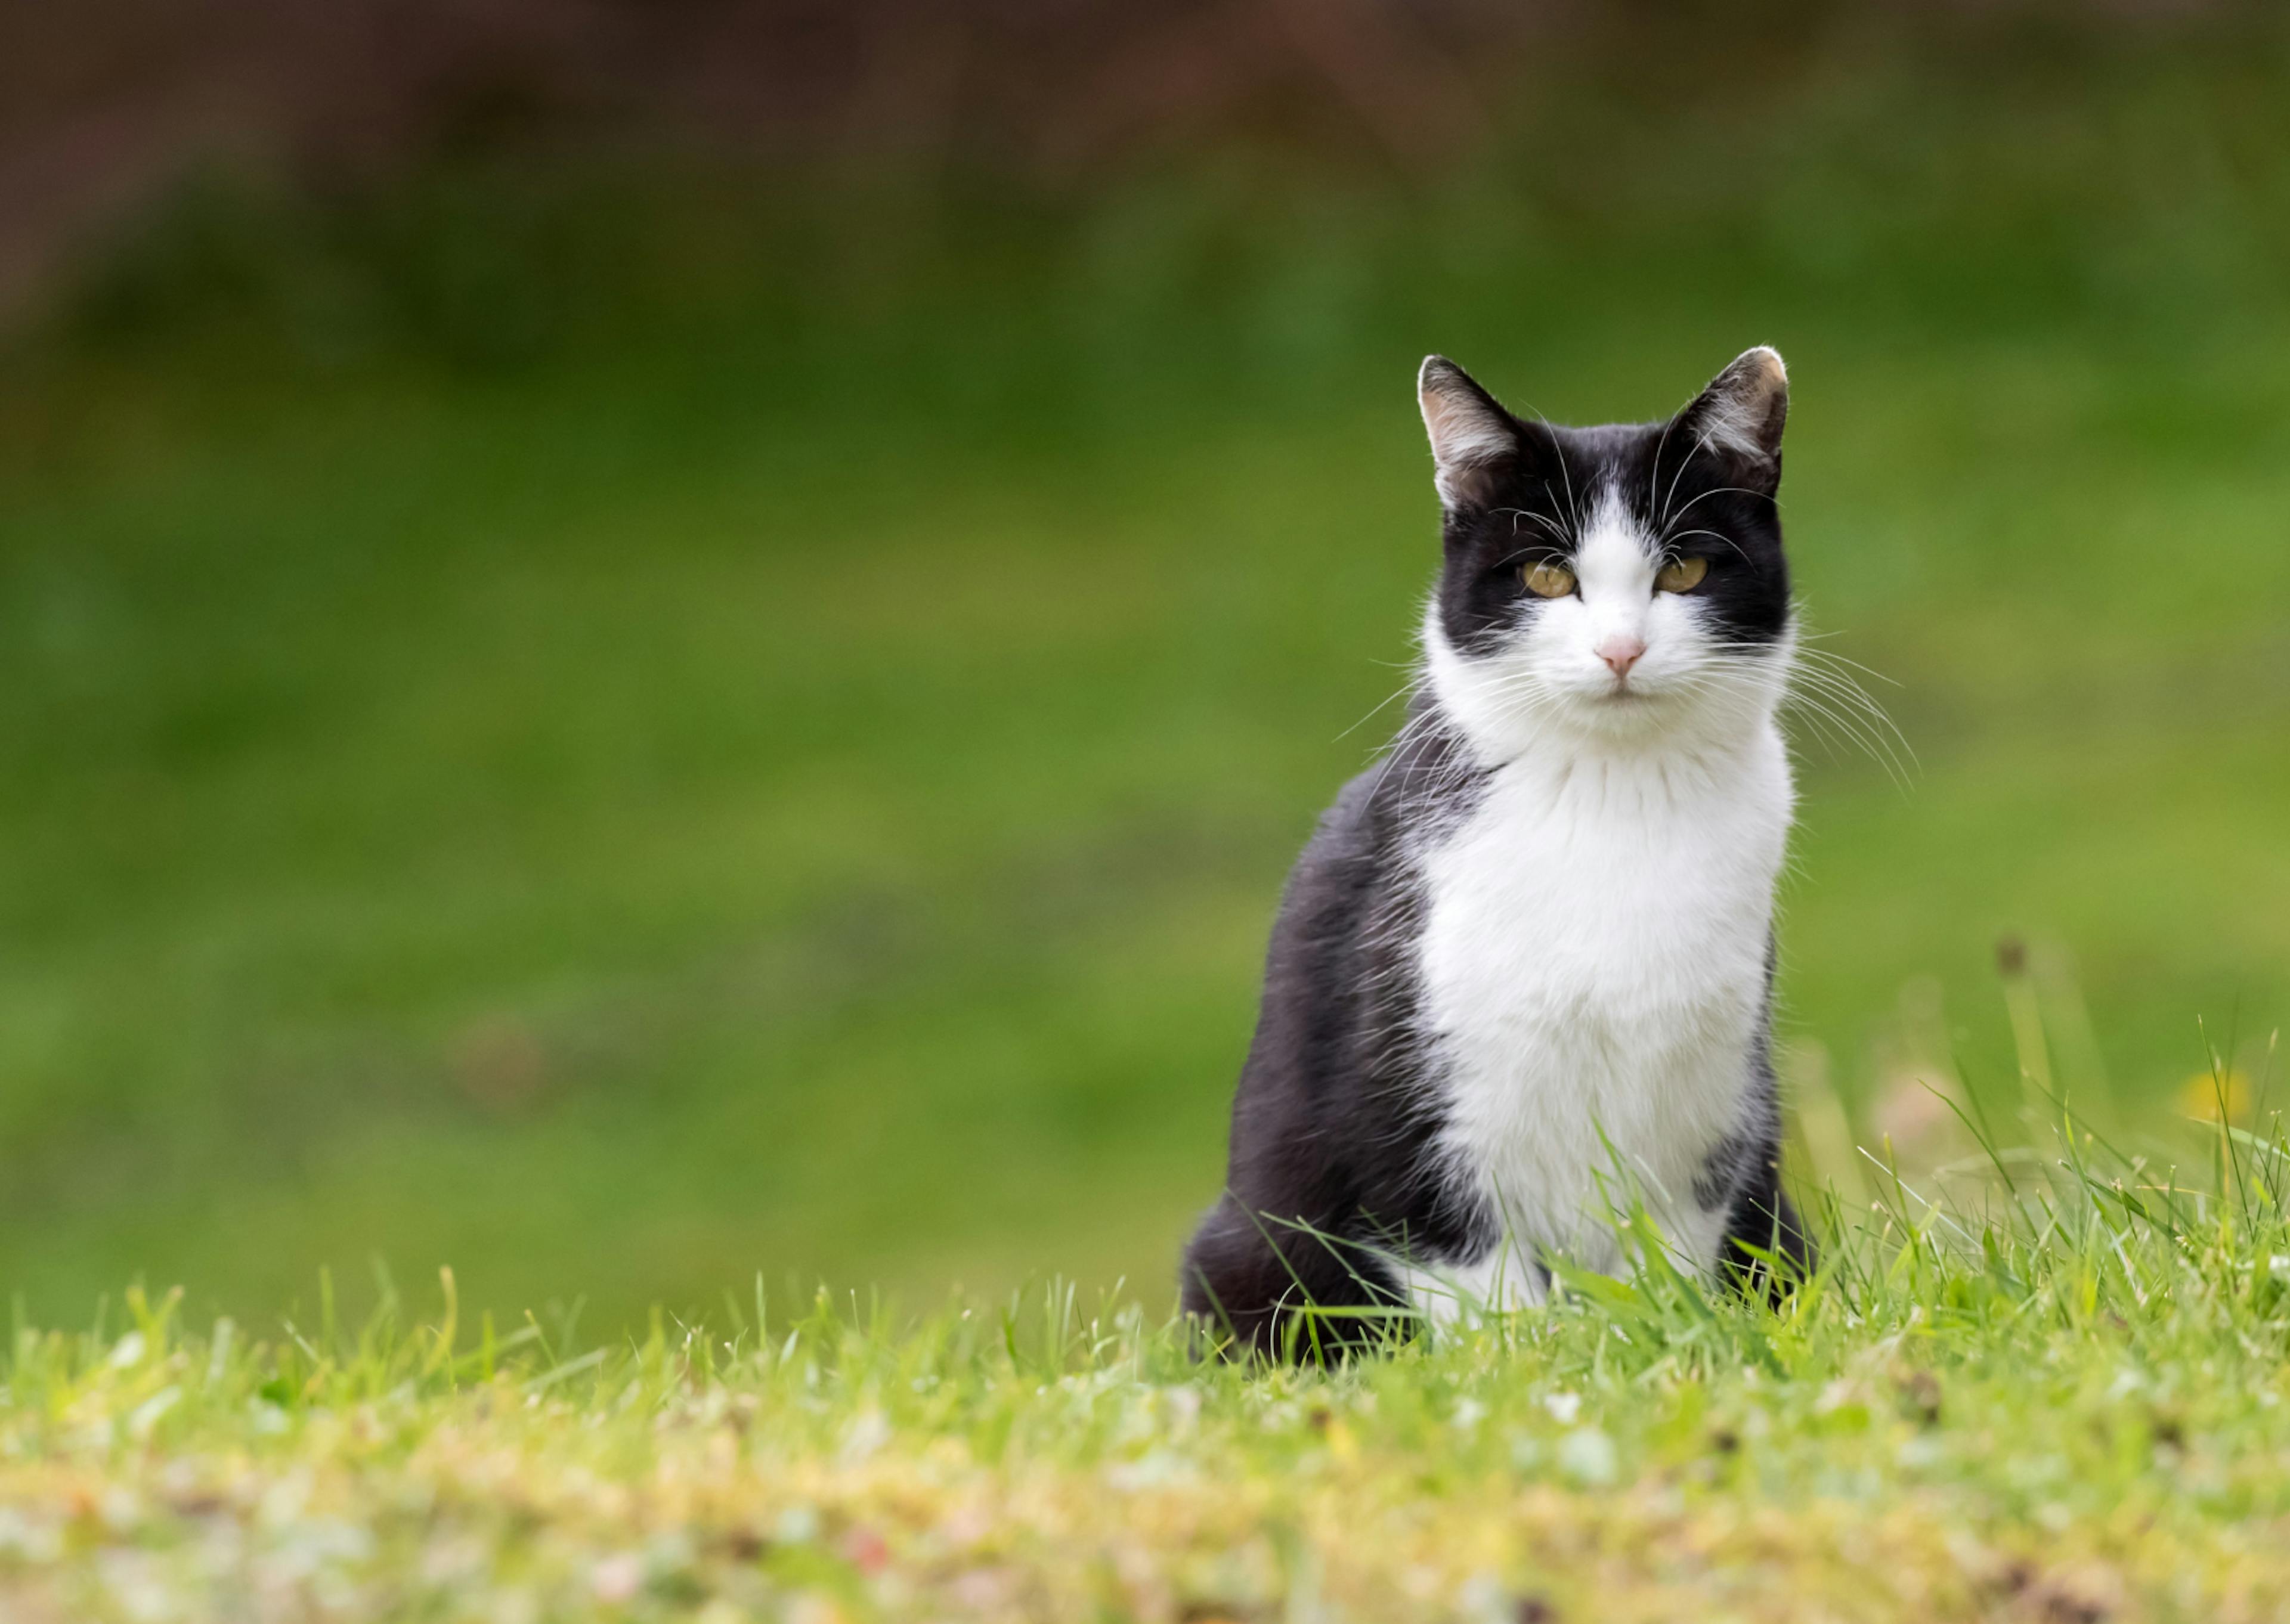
13, 1102, 2290, 1624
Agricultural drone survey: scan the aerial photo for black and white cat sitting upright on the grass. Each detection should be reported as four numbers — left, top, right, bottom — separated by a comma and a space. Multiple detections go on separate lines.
1184, 348, 1811, 1352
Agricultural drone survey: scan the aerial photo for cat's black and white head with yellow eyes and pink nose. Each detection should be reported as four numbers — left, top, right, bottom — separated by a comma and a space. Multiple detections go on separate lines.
1418, 348, 1796, 761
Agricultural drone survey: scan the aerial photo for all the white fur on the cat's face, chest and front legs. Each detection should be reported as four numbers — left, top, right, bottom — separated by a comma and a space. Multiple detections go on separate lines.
1410, 481, 1793, 1312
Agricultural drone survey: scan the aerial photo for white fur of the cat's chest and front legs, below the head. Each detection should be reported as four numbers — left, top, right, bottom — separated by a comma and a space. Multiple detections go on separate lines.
1420, 721, 1793, 1301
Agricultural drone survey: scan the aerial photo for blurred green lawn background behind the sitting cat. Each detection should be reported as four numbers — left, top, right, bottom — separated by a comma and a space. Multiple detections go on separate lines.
0, 2, 2290, 1328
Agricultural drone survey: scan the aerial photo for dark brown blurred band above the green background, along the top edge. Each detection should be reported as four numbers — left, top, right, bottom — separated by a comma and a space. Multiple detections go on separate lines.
0, 0, 2265, 307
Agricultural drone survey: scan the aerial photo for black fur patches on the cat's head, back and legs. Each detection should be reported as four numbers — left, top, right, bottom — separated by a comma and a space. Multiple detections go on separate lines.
1181, 353, 1811, 1356
